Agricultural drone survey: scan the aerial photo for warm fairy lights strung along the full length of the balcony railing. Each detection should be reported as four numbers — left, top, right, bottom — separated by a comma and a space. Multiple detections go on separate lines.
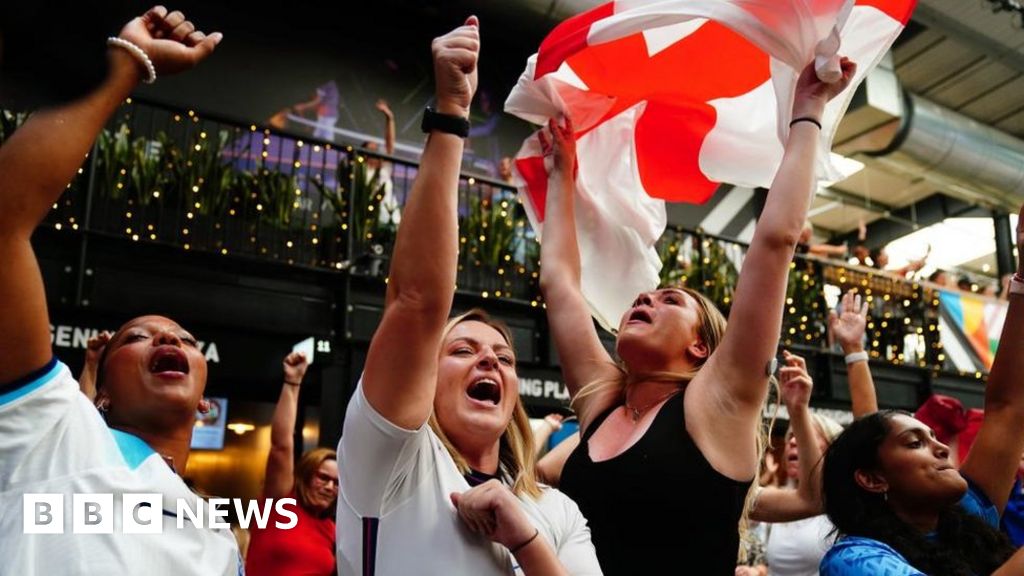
36, 99, 984, 378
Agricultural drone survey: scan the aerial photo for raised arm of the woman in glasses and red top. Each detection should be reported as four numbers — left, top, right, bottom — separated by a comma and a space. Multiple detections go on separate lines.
263, 352, 309, 498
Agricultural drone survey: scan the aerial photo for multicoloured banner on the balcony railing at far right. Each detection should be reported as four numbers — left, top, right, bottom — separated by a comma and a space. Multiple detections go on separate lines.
939, 290, 1007, 370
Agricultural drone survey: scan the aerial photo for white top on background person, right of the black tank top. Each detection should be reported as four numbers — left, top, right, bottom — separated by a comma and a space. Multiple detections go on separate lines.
765, 515, 834, 576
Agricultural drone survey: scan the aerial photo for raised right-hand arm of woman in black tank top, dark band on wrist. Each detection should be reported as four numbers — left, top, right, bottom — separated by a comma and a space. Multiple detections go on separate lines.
686, 58, 856, 480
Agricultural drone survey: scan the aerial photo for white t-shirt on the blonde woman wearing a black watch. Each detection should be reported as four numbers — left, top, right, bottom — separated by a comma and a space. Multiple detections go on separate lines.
337, 382, 601, 576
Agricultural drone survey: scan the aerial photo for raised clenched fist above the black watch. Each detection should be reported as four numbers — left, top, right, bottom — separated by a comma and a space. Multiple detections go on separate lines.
430, 16, 480, 118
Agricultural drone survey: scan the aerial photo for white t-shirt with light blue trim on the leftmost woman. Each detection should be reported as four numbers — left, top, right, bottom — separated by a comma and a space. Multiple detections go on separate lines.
0, 362, 244, 576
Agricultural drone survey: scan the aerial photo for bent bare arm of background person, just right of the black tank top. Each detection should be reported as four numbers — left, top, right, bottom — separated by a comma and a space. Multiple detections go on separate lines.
751, 351, 822, 522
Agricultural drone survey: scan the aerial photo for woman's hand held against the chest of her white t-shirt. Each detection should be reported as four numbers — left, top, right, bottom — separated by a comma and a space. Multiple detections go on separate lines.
451, 480, 537, 551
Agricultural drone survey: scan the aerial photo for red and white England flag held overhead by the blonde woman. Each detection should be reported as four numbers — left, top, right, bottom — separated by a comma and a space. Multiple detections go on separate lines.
505, 0, 916, 328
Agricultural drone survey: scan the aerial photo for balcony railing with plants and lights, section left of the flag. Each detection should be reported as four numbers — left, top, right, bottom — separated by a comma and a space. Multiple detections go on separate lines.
38, 99, 540, 305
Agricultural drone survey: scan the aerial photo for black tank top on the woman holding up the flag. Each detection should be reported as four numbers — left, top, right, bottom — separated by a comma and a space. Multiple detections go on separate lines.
559, 387, 751, 576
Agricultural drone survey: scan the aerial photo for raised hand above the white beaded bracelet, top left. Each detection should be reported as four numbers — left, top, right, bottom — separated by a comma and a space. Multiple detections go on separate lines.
118, 6, 223, 77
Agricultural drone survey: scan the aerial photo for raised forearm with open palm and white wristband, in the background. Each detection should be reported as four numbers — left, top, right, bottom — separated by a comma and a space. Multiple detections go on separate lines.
828, 290, 879, 418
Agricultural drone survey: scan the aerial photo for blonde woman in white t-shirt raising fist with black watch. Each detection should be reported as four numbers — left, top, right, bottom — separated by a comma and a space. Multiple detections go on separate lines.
337, 17, 600, 576
